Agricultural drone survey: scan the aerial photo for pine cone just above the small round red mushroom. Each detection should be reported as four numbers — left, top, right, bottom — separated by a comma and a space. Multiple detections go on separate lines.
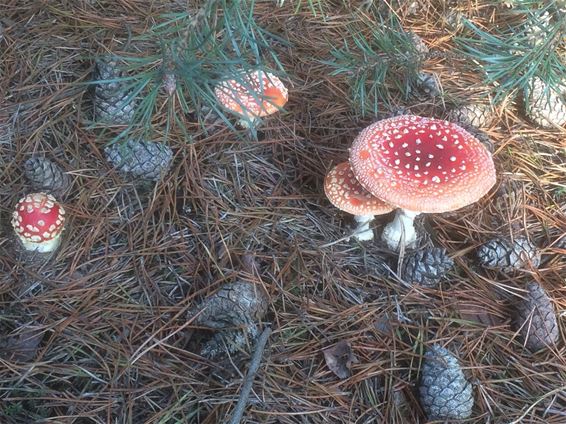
24, 157, 71, 197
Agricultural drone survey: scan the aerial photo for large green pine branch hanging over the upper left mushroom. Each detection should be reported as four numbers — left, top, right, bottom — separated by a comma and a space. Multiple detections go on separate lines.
94, 0, 286, 142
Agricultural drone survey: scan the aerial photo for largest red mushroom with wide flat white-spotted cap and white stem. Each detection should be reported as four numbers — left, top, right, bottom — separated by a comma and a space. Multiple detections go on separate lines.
350, 115, 495, 249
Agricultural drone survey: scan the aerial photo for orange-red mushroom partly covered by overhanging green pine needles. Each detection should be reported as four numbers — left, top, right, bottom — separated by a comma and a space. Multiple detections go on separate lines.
214, 71, 289, 127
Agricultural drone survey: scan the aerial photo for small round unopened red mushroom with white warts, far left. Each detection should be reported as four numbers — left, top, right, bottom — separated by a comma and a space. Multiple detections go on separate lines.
12, 193, 65, 253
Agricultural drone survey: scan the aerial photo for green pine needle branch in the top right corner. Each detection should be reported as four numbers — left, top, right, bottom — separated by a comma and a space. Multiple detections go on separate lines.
456, 0, 566, 102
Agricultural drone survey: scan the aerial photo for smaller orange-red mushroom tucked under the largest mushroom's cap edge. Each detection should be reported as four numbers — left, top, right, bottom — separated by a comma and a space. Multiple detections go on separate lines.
324, 162, 394, 241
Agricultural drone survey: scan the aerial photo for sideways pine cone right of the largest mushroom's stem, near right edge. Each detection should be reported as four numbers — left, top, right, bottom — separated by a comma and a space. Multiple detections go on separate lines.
478, 237, 540, 272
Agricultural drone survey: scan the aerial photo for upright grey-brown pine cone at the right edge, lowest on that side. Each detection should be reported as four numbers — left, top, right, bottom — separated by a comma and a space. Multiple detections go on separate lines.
515, 283, 559, 351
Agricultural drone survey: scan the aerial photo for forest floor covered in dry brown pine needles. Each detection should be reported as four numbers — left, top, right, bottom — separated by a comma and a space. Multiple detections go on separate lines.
0, 0, 566, 424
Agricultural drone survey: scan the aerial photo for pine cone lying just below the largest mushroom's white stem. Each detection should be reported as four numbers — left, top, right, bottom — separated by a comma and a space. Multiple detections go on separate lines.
402, 247, 454, 287
